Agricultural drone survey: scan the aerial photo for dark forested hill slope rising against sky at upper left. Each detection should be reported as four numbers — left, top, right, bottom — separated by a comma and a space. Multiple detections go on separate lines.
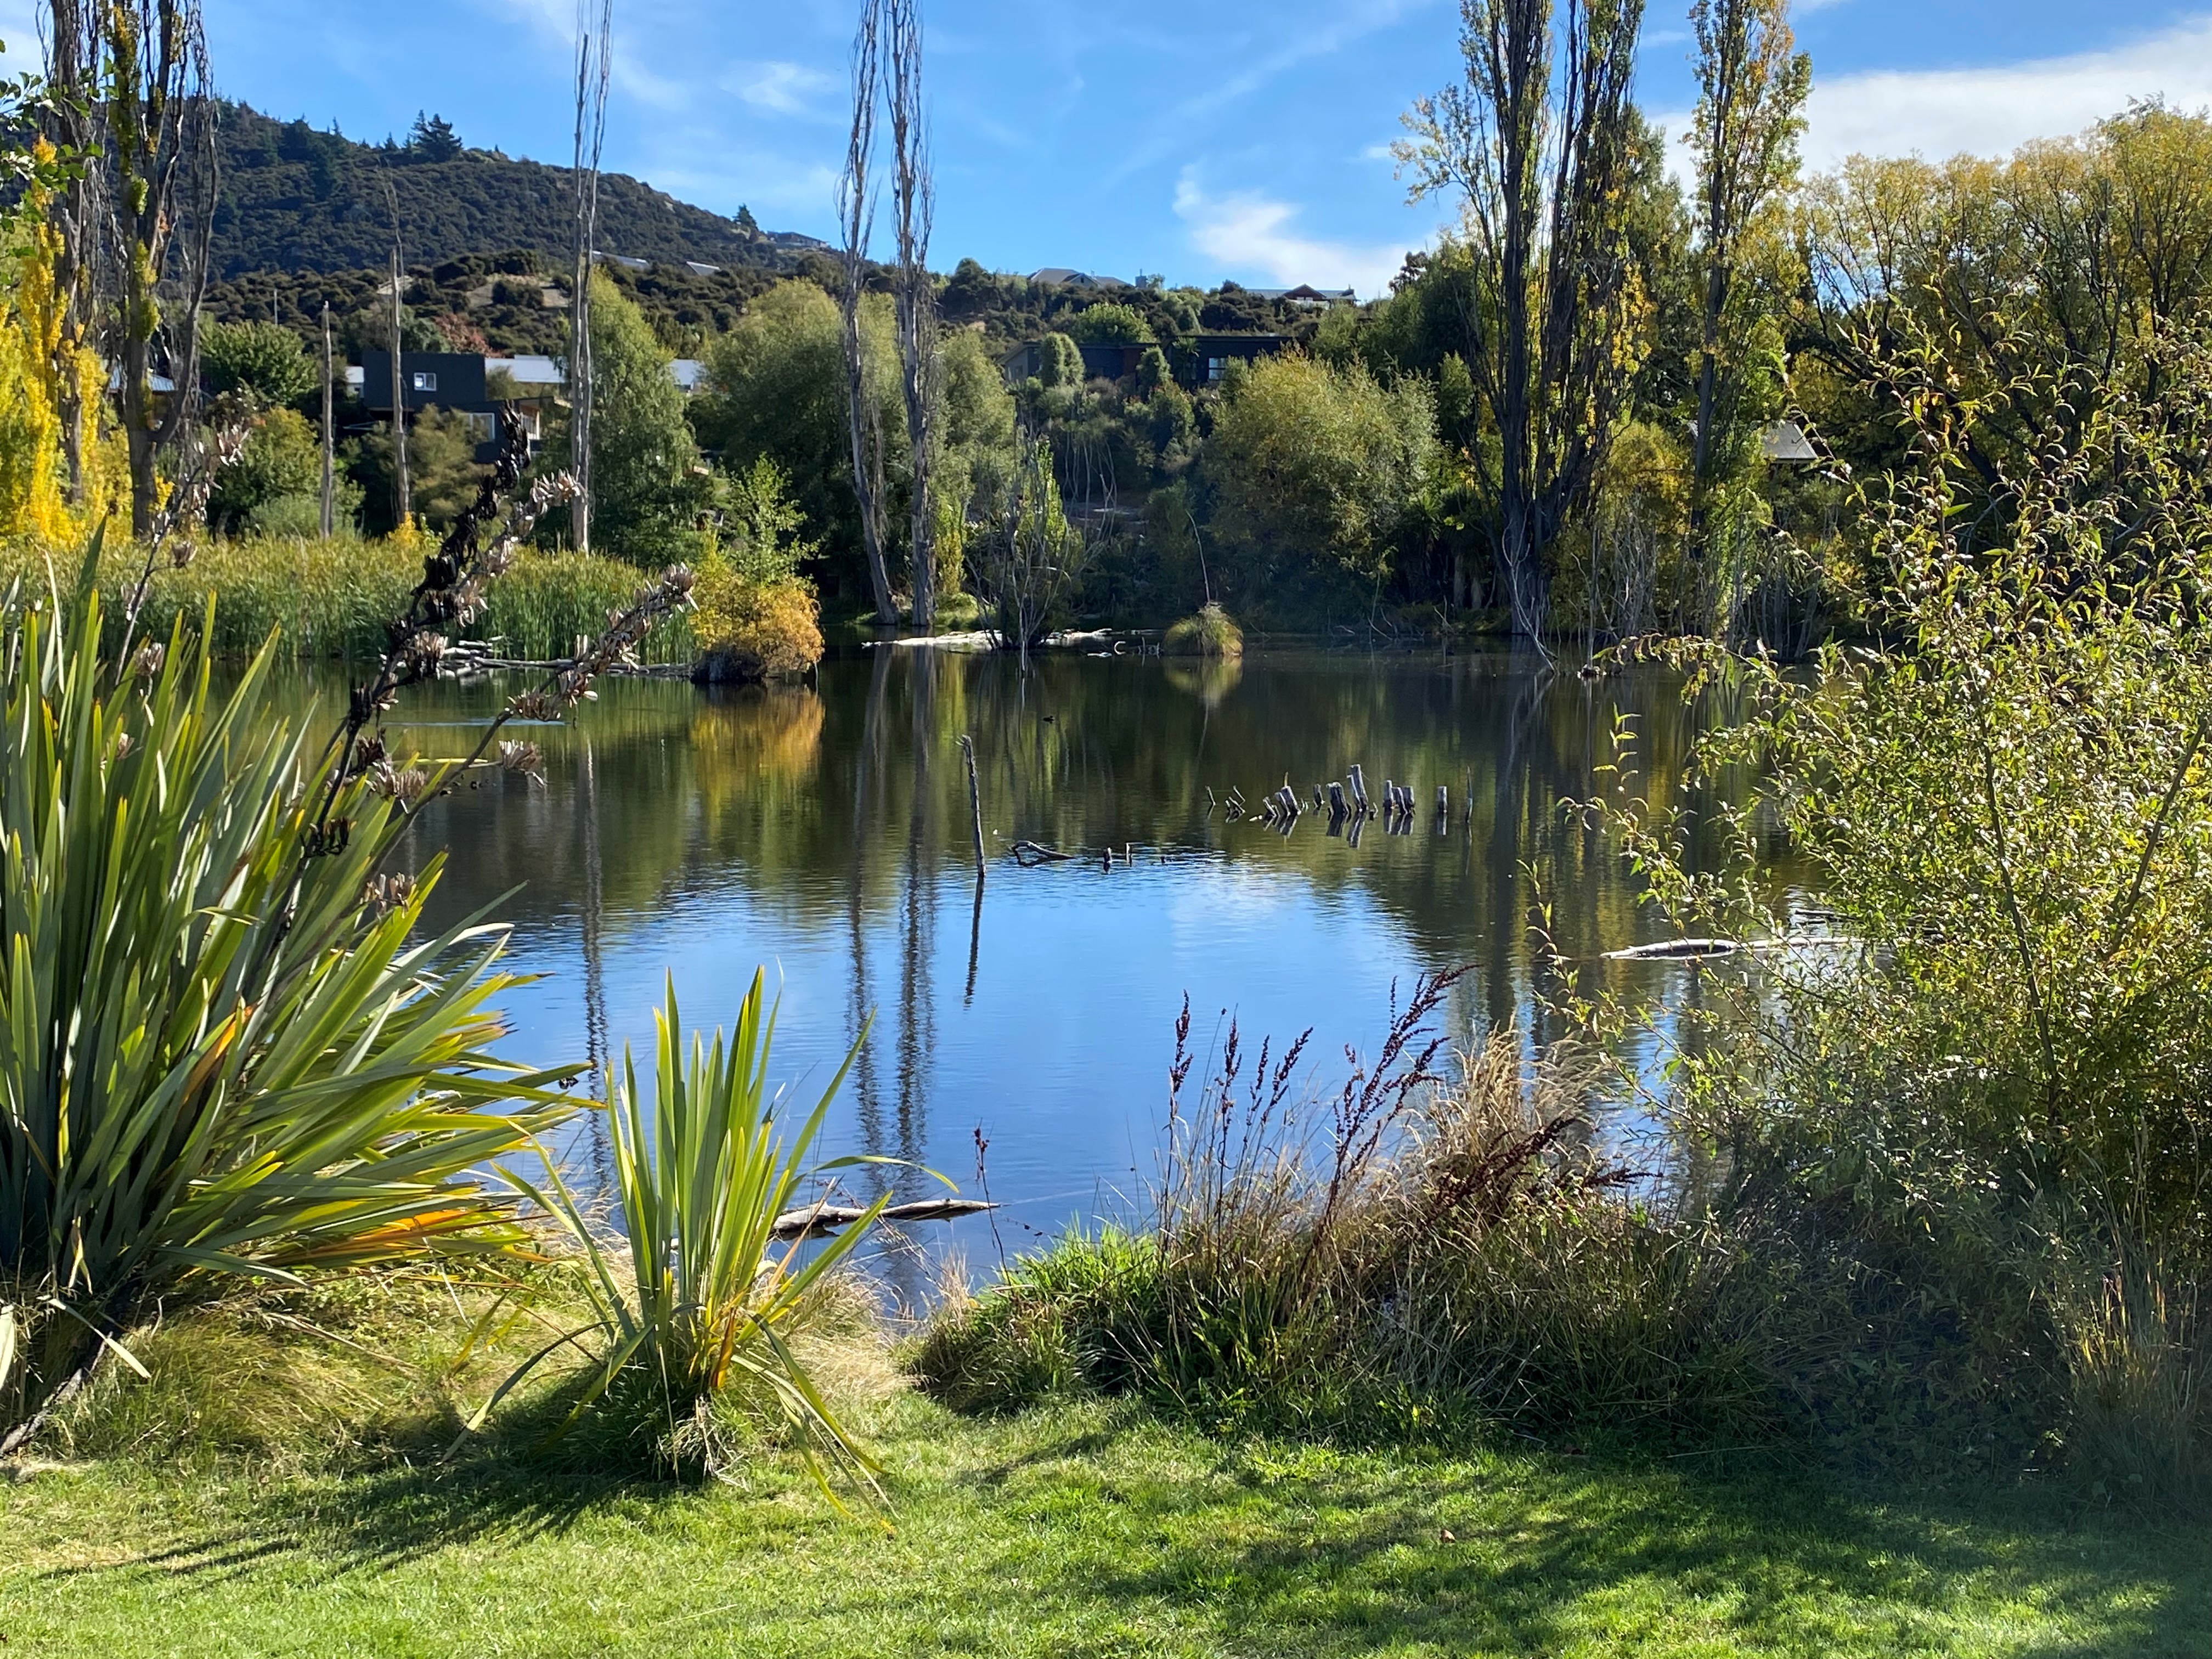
215, 104, 814, 276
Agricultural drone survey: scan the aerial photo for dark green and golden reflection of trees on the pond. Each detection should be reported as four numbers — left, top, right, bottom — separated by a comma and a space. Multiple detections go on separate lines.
292, 650, 1760, 1203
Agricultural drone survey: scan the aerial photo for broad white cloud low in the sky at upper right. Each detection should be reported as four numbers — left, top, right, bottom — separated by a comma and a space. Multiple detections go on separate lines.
1657, 15, 2212, 175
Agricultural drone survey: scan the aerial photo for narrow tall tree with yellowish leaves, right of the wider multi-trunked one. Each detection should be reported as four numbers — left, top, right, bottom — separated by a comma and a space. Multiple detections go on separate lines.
1690, 0, 1812, 522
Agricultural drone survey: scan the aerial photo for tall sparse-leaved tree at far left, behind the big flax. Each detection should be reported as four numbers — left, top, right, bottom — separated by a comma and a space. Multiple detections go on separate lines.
47, 0, 219, 538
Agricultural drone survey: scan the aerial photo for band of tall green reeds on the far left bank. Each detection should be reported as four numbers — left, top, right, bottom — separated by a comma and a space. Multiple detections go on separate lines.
0, 535, 692, 662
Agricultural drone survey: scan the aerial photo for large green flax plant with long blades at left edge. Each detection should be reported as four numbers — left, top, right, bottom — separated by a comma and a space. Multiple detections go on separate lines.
0, 579, 566, 1451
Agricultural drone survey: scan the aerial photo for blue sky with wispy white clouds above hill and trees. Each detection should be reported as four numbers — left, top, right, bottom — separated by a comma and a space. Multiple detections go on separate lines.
0, 0, 2212, 292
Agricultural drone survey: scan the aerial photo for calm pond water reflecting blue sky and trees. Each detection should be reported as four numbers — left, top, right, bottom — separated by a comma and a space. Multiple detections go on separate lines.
272, 650, 1725, 1274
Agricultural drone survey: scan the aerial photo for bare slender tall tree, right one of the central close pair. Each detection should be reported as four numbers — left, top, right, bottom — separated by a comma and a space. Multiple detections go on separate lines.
887, 0, 938, 633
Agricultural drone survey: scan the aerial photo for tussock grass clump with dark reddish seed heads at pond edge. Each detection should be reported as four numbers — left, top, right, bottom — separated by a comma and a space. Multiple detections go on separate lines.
909, 975, 1776, 1440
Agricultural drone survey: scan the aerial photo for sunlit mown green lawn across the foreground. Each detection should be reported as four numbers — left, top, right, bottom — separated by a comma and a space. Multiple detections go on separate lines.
0, 1396, 2212, 1659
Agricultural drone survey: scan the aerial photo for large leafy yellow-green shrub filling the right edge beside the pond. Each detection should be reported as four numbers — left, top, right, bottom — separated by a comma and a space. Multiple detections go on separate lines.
1593, 320, 2212, 1504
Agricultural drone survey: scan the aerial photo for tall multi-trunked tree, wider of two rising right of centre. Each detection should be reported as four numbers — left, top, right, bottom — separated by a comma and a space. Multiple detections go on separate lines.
1396, 0, 1644, 635
